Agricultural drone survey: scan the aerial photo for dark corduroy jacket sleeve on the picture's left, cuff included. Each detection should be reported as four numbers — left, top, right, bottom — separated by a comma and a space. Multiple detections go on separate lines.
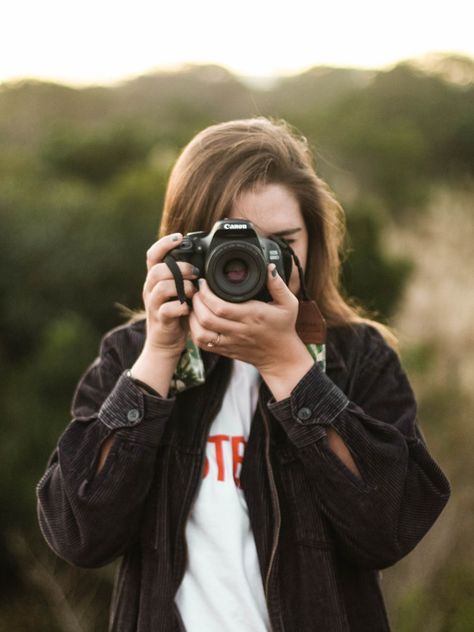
37, 332, 174, 567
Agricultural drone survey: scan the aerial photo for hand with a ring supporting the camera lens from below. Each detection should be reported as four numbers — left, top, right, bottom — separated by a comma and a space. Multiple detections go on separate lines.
189, 264, 306, 373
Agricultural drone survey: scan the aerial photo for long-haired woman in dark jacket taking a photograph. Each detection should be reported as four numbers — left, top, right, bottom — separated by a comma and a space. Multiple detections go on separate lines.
38, 118, 450, 632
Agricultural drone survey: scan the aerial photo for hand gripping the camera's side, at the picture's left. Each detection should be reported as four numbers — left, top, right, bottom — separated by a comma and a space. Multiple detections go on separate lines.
143, 233, 199, 359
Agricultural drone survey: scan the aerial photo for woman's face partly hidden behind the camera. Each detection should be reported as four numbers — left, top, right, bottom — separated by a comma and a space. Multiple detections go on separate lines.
229, 184, 308, 294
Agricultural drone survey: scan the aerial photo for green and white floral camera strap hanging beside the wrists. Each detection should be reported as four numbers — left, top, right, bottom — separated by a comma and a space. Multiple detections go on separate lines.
169, 336, 326, 396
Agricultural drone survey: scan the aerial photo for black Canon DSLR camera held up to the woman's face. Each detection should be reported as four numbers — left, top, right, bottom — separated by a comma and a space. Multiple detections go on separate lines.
169, 219, 292, 303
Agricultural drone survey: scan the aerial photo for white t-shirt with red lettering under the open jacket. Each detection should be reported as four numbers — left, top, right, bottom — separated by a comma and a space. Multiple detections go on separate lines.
175, 360, 270, 632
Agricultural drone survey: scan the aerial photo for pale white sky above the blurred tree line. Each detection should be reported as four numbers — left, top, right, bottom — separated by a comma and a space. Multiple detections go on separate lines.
0, 0, 474, 85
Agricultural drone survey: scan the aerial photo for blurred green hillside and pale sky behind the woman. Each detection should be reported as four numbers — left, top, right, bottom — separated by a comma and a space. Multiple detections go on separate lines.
0, 0, 474, 632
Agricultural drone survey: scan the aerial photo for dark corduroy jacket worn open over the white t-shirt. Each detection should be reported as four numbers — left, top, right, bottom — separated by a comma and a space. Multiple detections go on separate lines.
37, 321, 450, 632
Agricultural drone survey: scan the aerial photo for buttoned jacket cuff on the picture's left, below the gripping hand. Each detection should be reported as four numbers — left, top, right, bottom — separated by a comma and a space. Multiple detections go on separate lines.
98, 371, 176, 445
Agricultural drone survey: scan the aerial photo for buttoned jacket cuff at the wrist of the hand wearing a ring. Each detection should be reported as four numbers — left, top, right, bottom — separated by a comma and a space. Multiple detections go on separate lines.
267, 363, 349, 448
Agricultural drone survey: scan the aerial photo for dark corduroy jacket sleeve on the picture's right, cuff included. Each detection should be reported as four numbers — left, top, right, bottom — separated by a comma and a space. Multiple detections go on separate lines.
268, 328, 450, 569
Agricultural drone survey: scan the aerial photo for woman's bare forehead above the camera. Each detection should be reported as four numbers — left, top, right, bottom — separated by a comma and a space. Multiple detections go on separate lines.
230, 184, 304, 232
